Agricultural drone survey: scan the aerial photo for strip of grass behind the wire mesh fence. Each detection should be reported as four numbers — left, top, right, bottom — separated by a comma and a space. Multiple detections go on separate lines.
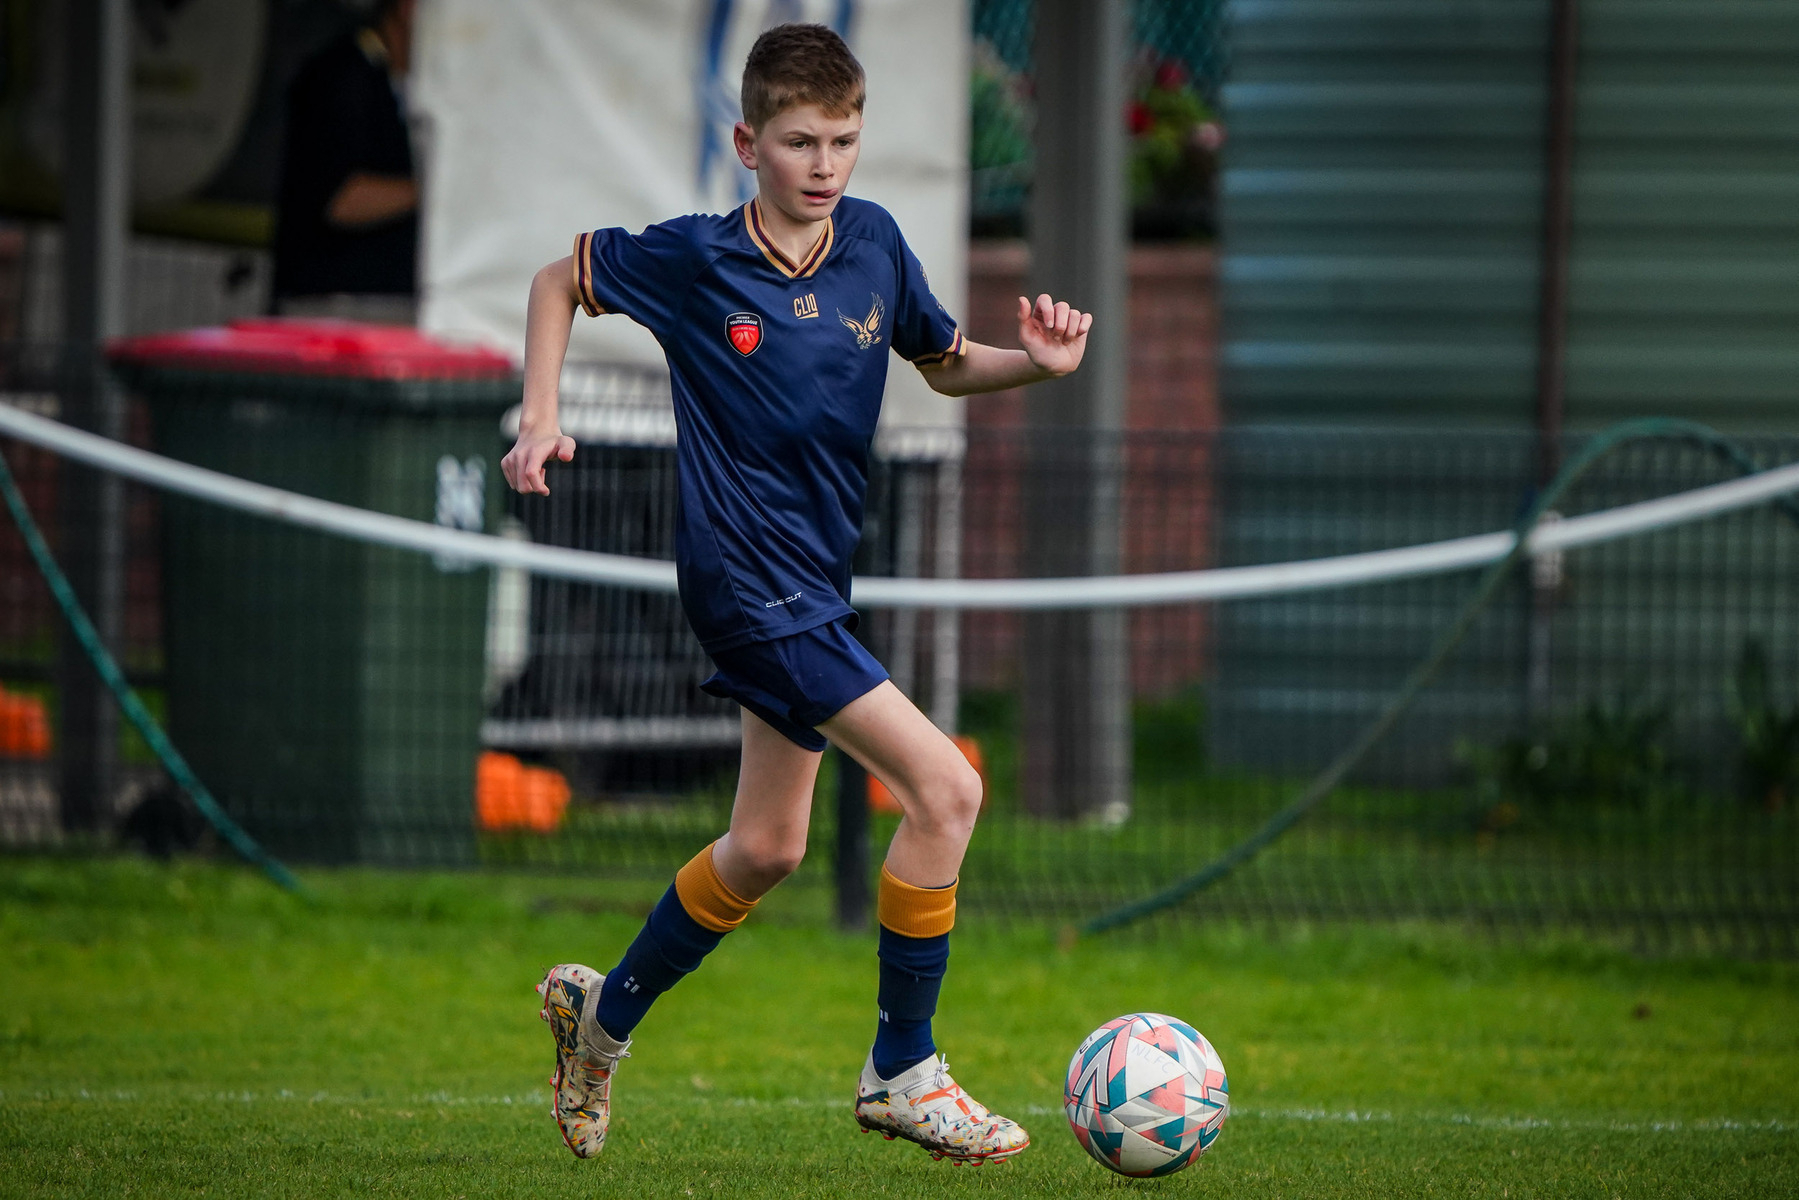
480, 693, 1799, 957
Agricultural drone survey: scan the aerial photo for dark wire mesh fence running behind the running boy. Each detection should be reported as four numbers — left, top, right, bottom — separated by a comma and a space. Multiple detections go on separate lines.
0, 354, 1799, 954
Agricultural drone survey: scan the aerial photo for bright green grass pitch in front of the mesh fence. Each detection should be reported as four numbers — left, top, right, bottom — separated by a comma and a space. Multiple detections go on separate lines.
0, 858, 1799, 1198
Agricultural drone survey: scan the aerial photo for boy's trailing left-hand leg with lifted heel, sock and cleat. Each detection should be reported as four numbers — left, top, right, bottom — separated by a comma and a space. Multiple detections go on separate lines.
538, 711, 820, 1159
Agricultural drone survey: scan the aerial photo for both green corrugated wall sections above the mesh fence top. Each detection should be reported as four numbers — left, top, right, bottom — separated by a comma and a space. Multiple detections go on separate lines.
1222, 0, 1799, 430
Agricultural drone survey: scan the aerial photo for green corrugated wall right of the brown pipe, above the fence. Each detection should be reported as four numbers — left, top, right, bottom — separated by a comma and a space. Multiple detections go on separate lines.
1569, 0, 1799, 432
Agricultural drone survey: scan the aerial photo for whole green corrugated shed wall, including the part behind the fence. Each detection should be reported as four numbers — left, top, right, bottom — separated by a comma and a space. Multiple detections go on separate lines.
1211, 0, 1799, 786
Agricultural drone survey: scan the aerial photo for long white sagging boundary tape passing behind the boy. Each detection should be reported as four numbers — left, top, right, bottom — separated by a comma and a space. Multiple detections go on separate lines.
10, 405, 1799, 608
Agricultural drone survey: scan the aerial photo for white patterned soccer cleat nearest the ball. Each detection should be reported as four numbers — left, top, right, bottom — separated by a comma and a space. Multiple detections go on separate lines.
856, 1054, 1031, 1166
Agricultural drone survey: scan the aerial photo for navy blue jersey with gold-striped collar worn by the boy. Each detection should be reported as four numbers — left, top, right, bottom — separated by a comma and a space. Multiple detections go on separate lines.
574, 198, 962, 651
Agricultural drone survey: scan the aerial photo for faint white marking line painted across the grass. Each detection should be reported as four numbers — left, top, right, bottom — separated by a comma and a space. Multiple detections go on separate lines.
0, 1088, 1799, 1133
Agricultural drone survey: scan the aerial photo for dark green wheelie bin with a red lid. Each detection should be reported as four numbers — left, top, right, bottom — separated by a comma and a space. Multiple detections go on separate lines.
112, 320, 520, 865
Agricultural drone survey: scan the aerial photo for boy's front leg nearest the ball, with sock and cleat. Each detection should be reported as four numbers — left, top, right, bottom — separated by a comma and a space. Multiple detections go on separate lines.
819, 682, 1031, 1160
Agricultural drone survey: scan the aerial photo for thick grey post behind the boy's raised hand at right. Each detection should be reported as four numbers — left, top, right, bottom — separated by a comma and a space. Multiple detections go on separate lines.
1020, 0, 1130, 817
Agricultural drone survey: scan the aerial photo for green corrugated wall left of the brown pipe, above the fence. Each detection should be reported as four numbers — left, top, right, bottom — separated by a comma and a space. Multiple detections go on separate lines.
1222, 0, 1547, 425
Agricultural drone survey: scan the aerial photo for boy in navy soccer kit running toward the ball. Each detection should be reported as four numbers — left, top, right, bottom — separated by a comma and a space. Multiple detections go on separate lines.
502, 25, 1092, 1162
